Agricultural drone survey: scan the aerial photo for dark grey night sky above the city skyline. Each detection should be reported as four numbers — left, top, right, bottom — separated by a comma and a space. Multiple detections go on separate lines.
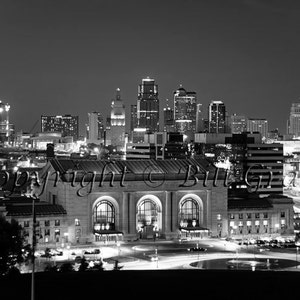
0, 0, 300, 134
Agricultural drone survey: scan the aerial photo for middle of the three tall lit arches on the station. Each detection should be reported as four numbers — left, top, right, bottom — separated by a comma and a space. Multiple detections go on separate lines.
136, 195, 161, 239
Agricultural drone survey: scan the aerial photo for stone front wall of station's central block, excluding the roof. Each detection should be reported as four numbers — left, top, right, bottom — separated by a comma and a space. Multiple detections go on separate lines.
36, 159, 228, 243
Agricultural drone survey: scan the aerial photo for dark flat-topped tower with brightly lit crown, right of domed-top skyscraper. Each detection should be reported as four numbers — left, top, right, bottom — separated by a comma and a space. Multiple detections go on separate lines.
208, 101, 227, 133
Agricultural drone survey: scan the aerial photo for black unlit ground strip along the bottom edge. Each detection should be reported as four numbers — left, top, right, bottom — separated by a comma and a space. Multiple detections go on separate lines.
0, 269, 300, 300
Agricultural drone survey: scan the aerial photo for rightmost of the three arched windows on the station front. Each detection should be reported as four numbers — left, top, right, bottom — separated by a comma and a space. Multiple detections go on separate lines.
179, 198, 199, 227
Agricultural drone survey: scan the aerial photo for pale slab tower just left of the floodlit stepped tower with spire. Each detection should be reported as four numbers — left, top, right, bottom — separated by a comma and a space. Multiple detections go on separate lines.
87, 111, 104, 144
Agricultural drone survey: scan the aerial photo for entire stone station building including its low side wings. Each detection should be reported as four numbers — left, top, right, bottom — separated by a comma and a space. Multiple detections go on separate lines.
0, 159, 295, 245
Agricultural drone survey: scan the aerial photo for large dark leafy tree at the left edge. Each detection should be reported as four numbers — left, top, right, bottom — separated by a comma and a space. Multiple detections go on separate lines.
0, 216, 24, 275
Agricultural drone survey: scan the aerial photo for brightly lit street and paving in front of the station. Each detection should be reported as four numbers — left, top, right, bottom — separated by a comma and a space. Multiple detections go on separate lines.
27, 238, 300, 273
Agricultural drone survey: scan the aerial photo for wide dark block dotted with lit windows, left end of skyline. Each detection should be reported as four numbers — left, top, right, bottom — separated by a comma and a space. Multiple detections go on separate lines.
41, 115, 79, 140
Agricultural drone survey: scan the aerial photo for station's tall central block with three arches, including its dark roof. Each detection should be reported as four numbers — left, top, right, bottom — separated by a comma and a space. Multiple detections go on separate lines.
35, 159, 228, 243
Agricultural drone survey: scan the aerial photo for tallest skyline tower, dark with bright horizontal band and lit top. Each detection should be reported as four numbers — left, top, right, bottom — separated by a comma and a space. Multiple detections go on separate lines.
137, 77, 159, 132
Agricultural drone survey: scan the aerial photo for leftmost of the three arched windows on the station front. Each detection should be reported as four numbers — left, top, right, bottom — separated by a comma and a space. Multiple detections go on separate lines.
93, 200, 115, 231
